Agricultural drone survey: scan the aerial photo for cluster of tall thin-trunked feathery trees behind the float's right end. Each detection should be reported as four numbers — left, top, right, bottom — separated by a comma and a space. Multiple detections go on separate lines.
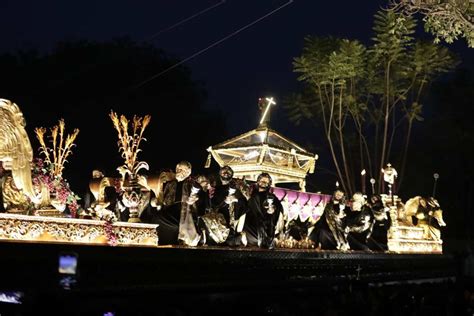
286, 10, 456, 193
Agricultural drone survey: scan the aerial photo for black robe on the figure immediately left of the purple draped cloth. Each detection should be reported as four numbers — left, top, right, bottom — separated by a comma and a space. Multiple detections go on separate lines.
244, 191, 283, 248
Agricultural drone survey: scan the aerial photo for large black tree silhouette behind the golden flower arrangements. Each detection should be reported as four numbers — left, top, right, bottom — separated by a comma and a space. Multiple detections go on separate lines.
0, 39, 225, 192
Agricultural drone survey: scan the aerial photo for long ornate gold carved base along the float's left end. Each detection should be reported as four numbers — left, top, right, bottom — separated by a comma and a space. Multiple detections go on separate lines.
0, 213, 158, 246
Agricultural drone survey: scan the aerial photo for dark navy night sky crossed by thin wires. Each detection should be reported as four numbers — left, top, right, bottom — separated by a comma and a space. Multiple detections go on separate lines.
0, 0, 472, 185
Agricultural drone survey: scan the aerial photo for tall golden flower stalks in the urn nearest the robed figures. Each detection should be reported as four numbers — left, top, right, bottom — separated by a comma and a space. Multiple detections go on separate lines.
109, 111, 151, 179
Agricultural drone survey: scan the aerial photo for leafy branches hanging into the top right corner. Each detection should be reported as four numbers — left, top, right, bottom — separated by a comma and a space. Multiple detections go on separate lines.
392, 0, 474, 48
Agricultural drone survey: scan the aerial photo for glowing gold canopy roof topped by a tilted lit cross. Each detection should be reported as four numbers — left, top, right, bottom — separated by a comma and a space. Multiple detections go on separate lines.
207, 98, 318, 191
